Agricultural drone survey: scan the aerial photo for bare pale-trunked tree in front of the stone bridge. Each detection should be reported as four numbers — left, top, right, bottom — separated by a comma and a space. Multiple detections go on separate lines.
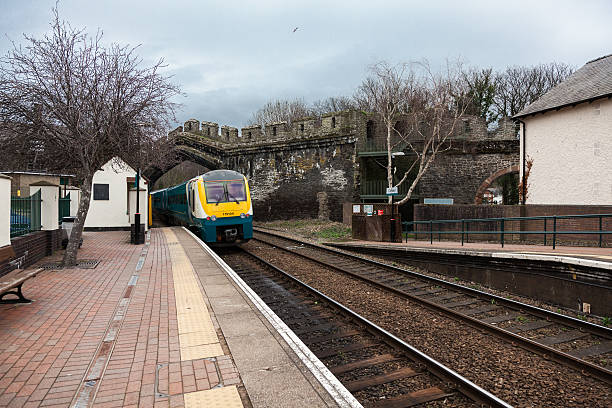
355, 61, 469, 205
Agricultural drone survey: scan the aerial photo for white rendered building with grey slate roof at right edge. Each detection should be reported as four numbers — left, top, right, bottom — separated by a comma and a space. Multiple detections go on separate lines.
514, 55, 612, 205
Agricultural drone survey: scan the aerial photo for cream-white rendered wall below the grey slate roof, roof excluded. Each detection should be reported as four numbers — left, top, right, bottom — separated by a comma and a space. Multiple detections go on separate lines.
521, 99, 612, 205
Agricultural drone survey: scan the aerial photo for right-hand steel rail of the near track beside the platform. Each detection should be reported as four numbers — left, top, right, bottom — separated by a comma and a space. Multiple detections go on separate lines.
240, 248, 512, 408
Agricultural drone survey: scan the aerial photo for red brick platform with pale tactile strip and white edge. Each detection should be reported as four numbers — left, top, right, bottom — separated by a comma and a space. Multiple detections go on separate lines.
0, 227, 356, 407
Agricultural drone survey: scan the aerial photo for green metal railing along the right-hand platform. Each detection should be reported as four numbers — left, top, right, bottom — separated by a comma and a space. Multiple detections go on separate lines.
402, 214, 612, 249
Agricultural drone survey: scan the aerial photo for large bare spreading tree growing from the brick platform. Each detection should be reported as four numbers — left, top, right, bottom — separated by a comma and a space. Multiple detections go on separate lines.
0, 10, 180, 265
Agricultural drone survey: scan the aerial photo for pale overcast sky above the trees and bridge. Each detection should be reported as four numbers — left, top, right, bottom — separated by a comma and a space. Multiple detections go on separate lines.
0, 0, 612, 127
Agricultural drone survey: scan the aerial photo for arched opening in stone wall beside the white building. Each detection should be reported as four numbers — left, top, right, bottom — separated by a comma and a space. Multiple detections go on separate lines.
474, 164, 519, 205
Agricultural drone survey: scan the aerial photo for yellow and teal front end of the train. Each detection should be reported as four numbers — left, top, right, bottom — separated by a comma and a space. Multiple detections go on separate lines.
198, 170, 253, 244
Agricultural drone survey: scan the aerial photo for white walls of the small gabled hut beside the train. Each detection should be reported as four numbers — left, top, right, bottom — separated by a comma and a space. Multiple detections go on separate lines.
85, 160, 148, 228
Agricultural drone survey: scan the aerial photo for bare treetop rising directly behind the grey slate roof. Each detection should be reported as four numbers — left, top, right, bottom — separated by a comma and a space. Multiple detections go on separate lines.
495, 62, 574, 117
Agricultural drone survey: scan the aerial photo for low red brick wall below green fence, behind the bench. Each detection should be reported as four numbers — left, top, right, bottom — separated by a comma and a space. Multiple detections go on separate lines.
0, 229, 62, 276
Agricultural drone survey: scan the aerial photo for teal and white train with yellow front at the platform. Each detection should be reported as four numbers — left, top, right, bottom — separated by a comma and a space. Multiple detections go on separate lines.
150, 170, 253, 245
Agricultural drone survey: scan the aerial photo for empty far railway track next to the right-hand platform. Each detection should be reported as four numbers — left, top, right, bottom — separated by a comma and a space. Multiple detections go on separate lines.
250, 230, 612, 385
